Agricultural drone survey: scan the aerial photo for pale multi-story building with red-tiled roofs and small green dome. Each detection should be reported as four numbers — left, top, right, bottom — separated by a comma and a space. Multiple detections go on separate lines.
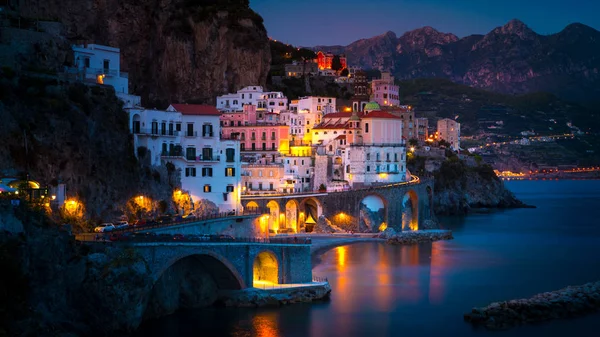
312, 102, 408, 187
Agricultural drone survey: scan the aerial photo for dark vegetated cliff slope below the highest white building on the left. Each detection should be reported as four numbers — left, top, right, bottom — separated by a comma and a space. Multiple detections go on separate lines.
0, 71, 173, 221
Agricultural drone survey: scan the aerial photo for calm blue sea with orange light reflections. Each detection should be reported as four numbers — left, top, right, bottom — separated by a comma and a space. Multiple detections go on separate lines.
138, 180, 600, 337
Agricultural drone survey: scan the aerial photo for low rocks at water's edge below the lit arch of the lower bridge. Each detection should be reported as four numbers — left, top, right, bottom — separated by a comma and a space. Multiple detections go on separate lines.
215, 282, 331, 308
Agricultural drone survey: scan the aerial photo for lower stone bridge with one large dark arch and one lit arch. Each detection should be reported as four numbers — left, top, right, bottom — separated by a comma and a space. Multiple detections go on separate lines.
126, 241, 312, 289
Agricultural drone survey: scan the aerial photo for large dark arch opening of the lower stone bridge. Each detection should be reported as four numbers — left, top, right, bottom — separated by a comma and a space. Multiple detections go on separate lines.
144, 254, 244, 319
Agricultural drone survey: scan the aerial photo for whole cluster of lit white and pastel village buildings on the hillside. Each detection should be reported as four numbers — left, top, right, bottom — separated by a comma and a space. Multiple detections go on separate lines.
73, 45, 458, 215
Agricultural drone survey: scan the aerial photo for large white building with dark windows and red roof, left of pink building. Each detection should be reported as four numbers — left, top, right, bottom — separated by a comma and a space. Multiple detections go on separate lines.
129, 104, 242, 211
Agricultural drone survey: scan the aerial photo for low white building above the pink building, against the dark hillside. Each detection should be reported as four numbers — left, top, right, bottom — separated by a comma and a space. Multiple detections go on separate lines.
217, 85, 288, 113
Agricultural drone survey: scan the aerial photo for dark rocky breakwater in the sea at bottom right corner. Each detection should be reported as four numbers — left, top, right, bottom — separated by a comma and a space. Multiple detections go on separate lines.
464, 282, 600, 330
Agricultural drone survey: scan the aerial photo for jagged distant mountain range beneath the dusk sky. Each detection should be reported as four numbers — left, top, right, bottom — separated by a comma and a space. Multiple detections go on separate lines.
313, 20, 600, 101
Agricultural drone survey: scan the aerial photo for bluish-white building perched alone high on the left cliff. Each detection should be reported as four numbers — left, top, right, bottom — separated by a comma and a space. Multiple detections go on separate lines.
72, 44, 140, 107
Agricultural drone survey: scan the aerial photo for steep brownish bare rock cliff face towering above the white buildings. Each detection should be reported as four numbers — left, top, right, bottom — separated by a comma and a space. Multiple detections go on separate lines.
19, 0, 271, 106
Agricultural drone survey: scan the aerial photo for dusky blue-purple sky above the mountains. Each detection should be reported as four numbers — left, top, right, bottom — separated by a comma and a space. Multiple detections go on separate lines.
250, 0, 600, 47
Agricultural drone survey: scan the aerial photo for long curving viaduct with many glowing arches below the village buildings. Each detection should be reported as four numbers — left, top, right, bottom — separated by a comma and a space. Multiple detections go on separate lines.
242, 176, 434, 233
